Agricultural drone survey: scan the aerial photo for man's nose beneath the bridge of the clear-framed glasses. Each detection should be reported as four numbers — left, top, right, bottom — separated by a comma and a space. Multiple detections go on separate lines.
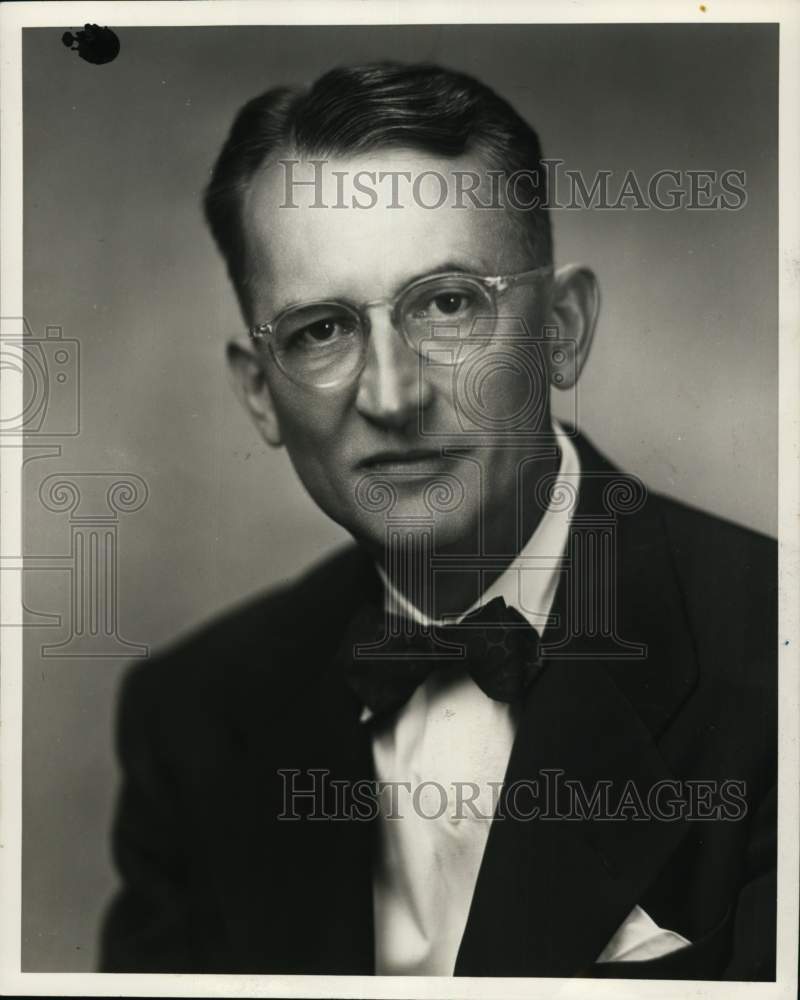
356, 306, 432, 430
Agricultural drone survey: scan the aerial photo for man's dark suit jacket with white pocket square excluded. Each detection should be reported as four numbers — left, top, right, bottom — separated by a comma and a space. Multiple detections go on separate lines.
102, 438, 777, 980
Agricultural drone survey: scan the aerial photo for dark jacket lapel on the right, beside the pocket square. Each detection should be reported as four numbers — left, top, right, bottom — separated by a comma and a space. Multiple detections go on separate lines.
455, 432, 696, 976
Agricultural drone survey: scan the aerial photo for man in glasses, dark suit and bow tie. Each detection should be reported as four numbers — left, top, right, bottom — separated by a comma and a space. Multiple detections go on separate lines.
98, 64, 776, 979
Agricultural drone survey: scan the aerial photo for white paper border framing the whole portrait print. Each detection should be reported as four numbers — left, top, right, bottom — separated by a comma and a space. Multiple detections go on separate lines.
0, 0, 800, 1000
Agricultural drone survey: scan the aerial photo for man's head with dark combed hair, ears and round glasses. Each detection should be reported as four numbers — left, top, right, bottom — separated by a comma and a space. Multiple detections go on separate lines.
206, 64, 597, 564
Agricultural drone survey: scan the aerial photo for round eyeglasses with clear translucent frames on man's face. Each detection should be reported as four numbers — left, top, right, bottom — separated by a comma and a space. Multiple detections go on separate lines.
248, 266, 552, 389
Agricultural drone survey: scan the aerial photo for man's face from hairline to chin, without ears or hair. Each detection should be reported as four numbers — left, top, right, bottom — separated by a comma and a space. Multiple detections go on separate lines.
234, 150, 560, 552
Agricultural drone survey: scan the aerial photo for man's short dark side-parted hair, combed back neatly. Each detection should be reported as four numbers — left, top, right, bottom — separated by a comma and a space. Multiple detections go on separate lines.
204, 62, 552, 311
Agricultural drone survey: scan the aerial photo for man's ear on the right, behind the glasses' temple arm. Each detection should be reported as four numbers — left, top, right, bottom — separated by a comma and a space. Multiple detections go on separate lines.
545, 264, 600, 389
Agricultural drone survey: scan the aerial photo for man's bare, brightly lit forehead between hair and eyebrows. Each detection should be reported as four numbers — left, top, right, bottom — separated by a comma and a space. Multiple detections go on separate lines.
243, 150, 530, 309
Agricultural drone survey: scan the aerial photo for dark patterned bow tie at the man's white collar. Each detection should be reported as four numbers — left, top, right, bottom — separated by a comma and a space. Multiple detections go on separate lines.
341, 597, 541, 716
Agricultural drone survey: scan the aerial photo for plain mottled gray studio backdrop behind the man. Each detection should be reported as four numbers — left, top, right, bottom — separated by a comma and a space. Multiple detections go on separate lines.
22, 25, 777, 971
